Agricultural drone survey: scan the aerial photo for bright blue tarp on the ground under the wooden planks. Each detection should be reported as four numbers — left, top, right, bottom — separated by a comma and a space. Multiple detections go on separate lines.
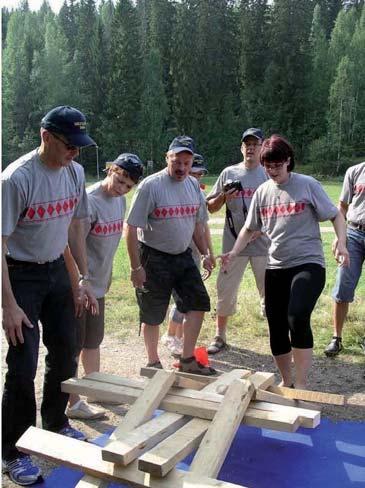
37, 419, 365, 488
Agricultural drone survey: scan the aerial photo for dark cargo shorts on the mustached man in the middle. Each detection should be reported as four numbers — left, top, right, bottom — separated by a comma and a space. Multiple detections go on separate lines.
136, 244, 210, 325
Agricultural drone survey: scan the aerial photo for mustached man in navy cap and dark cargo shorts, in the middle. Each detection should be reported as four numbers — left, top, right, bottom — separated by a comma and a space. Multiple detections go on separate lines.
126, 136, 215, 375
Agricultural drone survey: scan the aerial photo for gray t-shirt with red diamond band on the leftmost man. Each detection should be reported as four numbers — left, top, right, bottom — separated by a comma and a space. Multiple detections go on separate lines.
1, 149, 88, 262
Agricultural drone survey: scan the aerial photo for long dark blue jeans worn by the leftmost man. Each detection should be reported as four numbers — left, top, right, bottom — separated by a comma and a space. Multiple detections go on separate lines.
2, 257, 76, 460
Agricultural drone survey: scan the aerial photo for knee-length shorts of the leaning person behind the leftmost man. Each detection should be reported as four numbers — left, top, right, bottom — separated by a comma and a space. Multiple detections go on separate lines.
76, 297, 105, 353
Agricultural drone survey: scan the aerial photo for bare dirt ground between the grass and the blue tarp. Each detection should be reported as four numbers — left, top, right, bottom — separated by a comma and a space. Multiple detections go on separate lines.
2, 335, 365, 488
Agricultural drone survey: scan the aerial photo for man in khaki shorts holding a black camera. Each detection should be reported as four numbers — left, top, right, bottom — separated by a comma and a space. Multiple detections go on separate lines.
207, 127, 268, 354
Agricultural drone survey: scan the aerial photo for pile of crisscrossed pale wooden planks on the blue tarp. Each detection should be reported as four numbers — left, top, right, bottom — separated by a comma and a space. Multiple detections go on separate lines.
17, 368, 344, 488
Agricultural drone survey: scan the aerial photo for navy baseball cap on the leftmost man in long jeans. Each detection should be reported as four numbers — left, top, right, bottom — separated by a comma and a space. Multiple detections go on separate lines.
41, 105, 96, 147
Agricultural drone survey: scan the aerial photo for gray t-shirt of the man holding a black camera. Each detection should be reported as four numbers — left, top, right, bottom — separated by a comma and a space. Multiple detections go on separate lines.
207, 163, 269, 256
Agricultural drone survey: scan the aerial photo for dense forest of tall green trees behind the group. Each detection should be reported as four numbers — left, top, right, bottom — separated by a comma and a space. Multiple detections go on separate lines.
2, 0, 365, 174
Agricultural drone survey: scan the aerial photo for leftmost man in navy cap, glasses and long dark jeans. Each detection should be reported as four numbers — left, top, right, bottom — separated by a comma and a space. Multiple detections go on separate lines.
2, 106, 97, 486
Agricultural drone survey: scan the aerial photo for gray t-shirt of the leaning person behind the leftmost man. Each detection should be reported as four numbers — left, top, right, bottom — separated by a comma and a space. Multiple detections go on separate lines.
86, 182, 126, 298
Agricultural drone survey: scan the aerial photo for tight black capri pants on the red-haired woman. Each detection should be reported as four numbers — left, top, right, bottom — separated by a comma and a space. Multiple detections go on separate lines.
265, 263, 326, 356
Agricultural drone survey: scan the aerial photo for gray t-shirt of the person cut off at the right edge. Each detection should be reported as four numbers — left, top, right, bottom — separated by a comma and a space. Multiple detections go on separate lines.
340, 162, 365, 225
